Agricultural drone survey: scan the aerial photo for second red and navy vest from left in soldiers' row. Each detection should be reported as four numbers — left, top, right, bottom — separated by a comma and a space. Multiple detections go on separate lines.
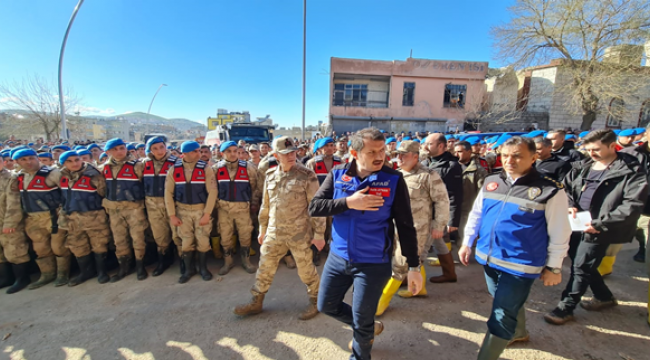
60, 165, 104, 214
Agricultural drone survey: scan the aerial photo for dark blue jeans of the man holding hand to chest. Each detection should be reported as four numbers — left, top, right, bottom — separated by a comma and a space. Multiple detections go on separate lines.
318, 253, 392, 360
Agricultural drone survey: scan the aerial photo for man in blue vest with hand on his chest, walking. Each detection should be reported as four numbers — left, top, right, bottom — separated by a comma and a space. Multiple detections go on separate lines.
309, 128, 422, 360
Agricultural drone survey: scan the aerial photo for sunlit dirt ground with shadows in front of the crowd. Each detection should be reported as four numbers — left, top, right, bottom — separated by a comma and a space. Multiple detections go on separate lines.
0, 244, 650, 360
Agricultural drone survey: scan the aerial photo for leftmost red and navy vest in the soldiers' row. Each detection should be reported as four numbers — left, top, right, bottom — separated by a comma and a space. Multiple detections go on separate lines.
18, 166, 61, 213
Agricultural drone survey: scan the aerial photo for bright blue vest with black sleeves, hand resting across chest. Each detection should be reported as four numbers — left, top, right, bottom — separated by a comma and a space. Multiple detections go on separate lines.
331, 163, 400, 264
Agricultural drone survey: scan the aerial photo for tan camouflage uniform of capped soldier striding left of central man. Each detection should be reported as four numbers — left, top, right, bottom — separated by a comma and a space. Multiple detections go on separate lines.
251, 163, 325, 298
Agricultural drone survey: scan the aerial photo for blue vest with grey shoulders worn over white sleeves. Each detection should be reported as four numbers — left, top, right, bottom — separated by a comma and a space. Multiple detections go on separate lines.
476, 169, 561, 278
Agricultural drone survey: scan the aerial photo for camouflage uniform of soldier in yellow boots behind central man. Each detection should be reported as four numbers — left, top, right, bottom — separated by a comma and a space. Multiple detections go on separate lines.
393, 163, 449, 281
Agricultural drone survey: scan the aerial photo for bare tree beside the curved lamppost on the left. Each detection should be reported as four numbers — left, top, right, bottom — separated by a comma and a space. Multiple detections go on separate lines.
0, 75, 80, 140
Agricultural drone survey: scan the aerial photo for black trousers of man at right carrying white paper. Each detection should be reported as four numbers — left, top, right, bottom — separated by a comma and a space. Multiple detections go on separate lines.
558, 232, 614, 313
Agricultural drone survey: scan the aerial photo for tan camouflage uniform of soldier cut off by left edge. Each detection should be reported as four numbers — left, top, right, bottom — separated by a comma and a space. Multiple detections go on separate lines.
0, 169, 29, 264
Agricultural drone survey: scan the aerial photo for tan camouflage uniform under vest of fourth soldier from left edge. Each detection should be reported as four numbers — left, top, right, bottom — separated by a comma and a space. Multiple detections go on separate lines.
99, 155, 149, 260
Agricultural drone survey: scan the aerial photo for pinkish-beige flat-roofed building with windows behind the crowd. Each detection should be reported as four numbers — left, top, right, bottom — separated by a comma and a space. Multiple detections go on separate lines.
330, 58, 488, 134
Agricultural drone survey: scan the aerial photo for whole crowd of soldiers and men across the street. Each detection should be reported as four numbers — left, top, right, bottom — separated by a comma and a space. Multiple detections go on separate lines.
0, 124, 650, 360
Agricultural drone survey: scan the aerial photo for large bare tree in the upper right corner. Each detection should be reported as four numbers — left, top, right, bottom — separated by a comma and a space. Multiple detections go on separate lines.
492, 0, 650, 130
